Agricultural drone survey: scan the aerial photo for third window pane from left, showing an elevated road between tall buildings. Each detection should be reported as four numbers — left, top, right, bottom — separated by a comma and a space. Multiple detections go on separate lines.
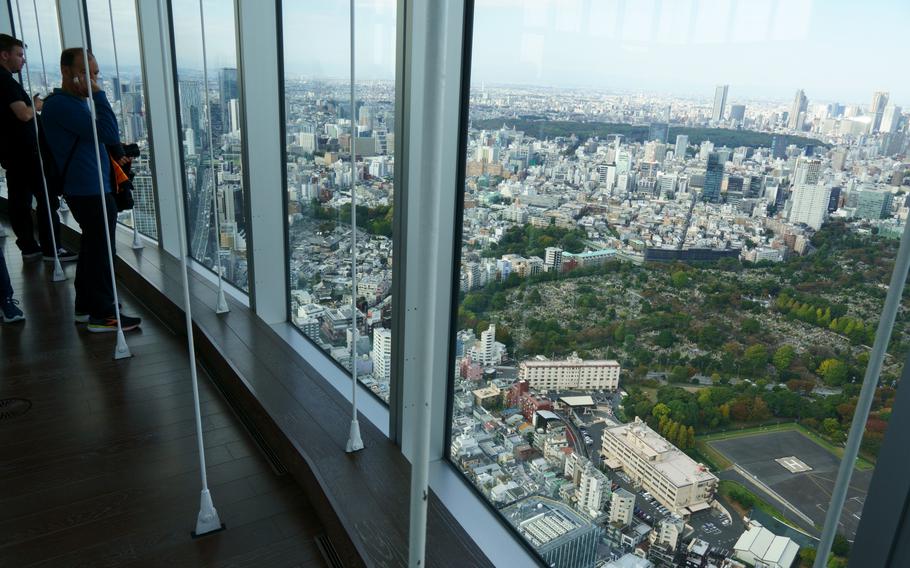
172, 0, 249, 291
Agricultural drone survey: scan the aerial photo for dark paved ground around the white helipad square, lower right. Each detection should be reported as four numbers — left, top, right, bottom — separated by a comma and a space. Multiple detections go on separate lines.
708, 430, 872, 540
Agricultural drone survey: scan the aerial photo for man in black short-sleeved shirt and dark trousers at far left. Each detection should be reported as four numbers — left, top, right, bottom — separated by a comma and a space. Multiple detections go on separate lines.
0, 34, 77, 261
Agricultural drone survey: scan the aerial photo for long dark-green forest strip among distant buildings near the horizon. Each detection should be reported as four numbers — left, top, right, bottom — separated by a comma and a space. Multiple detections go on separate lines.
472, 117, 830, 148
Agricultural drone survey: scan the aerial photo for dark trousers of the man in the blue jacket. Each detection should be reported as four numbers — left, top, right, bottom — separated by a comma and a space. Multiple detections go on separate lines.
66, 193, 117, 318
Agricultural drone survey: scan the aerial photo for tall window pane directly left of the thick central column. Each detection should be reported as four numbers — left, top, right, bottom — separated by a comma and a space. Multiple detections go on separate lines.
282, 0, 396, 402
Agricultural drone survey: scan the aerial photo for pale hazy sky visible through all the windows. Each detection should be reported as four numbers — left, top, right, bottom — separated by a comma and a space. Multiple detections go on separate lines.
13, 0, 910, 108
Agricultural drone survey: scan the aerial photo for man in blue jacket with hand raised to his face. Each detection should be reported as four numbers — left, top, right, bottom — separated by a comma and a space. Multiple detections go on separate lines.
41, 48, 140, 332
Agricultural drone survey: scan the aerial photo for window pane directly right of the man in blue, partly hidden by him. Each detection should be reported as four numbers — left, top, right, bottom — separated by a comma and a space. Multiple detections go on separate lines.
87, 0, 158, 239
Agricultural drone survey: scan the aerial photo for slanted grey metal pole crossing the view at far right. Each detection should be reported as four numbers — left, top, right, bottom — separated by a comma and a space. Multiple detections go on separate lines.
814, 216, 910, 568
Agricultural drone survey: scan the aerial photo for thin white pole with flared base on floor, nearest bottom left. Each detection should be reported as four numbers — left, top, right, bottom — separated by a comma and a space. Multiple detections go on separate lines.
158, 0, 224, 536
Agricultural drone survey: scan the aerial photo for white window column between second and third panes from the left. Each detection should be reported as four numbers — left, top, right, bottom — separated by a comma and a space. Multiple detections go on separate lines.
136, 0, 185, 258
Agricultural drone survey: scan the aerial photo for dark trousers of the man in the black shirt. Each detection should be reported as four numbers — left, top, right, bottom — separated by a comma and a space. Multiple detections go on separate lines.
6, 157, 60, 256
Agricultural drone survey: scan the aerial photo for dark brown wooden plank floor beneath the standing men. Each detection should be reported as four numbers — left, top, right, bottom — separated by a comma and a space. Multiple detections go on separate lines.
0, 225, 325, 568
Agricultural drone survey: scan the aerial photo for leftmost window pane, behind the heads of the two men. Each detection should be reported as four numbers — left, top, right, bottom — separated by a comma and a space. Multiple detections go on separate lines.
0, 0, 61, 201
